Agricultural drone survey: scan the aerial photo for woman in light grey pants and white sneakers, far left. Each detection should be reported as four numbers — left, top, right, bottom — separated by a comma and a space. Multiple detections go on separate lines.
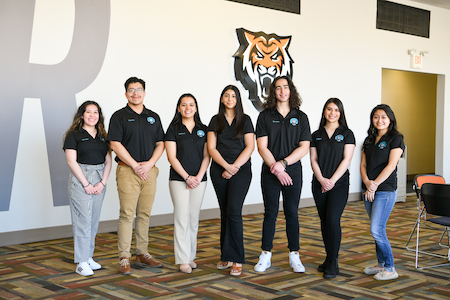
63, 101, 112, 276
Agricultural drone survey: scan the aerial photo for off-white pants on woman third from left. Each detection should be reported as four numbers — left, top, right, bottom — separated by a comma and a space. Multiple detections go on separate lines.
169, 180, 206, 265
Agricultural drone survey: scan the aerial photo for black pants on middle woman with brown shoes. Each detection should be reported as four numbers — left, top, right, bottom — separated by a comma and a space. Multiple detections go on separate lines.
210, 161, 252, 263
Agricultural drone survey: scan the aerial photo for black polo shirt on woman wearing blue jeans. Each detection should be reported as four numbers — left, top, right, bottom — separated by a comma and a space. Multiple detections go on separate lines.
362, 134, 405, 191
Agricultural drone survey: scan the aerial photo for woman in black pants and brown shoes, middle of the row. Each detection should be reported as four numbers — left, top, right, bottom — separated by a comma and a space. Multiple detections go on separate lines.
207, 85, 255, 276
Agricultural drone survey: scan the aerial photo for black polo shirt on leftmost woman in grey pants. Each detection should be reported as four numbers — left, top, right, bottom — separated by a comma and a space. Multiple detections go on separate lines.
63, 128, 109, 165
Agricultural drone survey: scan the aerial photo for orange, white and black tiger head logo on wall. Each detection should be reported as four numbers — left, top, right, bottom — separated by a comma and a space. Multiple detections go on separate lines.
233, 28, 294, 111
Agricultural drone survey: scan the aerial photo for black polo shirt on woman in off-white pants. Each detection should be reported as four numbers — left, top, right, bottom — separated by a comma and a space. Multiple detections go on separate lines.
164, 122, 207, 181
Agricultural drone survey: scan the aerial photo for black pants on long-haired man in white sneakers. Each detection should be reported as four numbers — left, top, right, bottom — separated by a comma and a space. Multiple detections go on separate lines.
261, 163, 303, 251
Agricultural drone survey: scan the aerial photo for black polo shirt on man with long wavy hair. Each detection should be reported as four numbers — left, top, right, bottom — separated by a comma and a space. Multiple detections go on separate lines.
256, 107, 311, 165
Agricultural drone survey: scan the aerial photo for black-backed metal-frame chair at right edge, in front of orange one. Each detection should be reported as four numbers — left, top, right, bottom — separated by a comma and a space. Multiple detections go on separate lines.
415, 183, 450, 270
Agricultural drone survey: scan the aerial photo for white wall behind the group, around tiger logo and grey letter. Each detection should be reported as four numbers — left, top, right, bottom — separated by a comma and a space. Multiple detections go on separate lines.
0, 0, 450, 236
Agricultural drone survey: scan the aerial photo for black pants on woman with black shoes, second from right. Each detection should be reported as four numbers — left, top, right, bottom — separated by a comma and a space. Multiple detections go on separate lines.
312, 179, 349, 263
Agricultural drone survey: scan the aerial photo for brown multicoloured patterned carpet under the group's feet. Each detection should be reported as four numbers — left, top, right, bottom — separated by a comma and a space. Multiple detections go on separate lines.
0, 197, 450, 299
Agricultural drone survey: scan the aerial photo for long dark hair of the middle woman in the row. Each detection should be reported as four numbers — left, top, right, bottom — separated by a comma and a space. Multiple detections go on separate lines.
214, 85, 244, 139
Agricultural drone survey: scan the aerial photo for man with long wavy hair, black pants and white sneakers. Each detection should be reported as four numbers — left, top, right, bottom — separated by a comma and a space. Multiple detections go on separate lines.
254, 76, 311, 273
